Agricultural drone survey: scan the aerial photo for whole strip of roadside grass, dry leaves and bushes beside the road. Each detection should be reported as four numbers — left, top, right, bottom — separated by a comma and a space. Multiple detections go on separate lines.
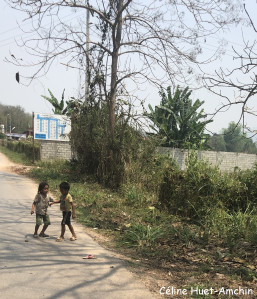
1, 142, 257, 294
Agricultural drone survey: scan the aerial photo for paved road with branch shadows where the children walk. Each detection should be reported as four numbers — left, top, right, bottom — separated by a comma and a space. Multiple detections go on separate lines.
0, 154, 156, 299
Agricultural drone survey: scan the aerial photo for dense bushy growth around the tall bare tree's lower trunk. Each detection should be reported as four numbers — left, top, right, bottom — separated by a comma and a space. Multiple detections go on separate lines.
71, 103, 149, 188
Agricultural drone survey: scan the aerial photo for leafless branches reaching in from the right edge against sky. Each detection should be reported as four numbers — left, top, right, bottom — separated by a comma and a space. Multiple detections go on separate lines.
205, 4, 257, 132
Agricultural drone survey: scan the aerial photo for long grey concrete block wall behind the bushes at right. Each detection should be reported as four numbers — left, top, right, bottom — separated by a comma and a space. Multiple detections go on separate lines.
158, 147, 257, 172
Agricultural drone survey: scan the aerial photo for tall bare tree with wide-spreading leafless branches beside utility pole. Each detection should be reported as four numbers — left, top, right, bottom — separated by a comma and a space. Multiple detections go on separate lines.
5, 0, 242, 135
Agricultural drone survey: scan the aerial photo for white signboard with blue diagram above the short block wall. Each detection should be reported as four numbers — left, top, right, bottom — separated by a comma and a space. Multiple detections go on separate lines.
34, 113, 71, 141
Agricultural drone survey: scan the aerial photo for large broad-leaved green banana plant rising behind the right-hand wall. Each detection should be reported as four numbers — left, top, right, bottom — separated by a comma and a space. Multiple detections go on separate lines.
147, 86, 212, 149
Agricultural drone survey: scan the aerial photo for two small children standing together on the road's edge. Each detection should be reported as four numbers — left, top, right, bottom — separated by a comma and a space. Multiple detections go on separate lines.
31, 182, 77, 242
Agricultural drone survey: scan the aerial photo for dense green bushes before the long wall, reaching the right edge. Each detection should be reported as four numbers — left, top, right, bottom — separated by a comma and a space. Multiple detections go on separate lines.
158, 153, 257, 221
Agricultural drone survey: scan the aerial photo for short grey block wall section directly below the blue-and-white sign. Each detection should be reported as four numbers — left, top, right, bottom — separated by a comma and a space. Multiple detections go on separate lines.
40, 140, 72, 160
